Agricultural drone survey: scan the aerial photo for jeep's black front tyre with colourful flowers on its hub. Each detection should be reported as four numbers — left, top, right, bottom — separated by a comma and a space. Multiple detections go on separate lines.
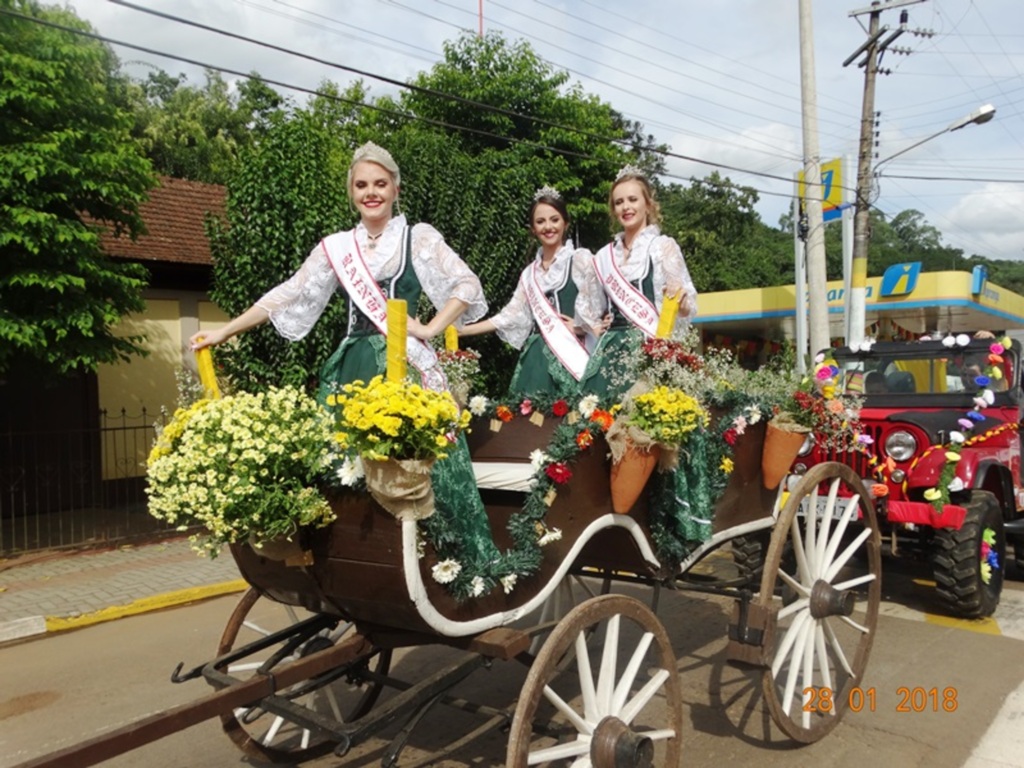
932, 490, 1007, 618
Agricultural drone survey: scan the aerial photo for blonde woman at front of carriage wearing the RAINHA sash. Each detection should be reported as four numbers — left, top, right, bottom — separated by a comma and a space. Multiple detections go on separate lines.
190, 142, 499, 562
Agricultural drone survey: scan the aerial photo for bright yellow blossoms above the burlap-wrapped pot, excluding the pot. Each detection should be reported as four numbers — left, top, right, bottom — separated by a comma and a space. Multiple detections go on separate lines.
328, 376, 470, 460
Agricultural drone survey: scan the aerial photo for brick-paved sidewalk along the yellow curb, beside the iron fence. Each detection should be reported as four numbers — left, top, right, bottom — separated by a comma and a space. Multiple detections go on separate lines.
0, 539, 244, 642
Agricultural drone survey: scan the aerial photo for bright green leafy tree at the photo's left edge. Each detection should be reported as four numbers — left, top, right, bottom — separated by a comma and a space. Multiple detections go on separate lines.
0, 0, 153, 375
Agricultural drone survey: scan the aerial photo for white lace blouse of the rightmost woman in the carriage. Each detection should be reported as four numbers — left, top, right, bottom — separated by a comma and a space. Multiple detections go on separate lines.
577, 224, 697, 337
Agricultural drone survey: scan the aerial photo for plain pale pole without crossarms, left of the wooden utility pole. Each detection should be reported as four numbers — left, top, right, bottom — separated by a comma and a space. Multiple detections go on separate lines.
797, 0, 830, 358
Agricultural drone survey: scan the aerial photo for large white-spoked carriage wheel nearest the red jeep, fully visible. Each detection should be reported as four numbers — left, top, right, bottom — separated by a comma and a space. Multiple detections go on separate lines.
758, 463, 882, 743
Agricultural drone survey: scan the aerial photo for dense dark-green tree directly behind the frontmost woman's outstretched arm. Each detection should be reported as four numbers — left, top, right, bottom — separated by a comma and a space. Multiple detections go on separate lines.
208, 105, 352, 391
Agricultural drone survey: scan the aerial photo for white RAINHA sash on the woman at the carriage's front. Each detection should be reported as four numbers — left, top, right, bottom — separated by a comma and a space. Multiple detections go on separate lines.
322, 229, 447, 392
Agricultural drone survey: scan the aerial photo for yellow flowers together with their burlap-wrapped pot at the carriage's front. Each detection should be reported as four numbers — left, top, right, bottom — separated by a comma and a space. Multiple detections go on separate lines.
328, 376, 470, 520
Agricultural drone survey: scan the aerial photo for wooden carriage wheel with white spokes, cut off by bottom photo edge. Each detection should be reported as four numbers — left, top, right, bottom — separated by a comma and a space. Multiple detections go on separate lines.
505, 595, 683, 768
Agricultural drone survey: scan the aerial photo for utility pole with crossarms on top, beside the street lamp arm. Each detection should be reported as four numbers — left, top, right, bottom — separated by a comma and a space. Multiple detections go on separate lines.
843, 0, 925, 346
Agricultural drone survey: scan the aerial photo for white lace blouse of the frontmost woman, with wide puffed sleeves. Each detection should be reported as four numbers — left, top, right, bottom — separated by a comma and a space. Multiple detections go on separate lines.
256, 216, 487, 341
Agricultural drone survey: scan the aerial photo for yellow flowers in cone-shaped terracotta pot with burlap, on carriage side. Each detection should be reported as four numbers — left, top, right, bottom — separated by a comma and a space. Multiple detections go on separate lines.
607, 383, 708, 513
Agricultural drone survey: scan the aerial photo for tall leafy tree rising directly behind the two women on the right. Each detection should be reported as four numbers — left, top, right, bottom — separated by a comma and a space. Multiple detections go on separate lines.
398, 33, 663, 249
